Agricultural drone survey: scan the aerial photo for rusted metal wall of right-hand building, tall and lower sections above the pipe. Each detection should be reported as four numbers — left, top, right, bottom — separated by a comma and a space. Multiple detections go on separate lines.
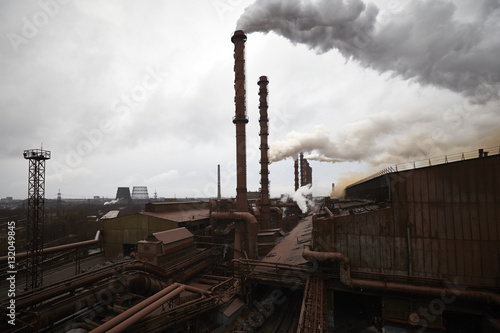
322, 155, 500, 287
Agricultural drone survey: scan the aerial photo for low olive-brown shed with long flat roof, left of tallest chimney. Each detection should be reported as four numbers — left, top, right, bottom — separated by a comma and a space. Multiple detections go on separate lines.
104, 201, 210, 258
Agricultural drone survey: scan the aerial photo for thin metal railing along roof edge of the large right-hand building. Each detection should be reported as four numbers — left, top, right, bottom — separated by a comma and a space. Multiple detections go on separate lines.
346, 146, 500, 188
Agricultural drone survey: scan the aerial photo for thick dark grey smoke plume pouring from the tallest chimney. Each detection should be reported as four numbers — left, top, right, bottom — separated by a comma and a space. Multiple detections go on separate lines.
237, 0, 500, 103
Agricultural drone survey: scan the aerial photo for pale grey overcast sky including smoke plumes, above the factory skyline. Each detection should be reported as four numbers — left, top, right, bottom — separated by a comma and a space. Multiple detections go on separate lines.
0, 0, 500, 199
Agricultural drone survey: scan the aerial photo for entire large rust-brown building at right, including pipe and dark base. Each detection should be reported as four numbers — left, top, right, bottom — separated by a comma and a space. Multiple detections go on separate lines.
312, 150, 500, 326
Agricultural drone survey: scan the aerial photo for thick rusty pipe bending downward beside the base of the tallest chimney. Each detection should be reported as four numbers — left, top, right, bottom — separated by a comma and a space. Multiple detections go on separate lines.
210, 212, 259, 259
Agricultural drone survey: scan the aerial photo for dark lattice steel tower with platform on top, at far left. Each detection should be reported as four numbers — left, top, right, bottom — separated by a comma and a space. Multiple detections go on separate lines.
23, 149, 50, 290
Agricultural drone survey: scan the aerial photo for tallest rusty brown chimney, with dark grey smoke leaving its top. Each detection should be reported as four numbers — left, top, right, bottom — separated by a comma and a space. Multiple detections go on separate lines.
231, 30, 248, 212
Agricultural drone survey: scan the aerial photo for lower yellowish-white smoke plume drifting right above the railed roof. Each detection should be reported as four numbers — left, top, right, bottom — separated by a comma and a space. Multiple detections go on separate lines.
269, 104, 500, 166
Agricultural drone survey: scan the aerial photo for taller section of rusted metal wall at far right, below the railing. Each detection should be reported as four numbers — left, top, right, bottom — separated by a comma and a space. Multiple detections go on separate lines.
391, 155, 500, 286
